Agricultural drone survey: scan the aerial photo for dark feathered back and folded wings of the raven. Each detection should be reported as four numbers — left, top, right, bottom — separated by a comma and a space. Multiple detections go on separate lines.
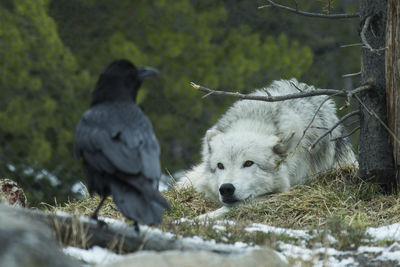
75, 102, 161, 182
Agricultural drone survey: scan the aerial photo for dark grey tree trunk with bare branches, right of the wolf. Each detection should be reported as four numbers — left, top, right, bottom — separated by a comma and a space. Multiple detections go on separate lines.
359, 0, 398, 192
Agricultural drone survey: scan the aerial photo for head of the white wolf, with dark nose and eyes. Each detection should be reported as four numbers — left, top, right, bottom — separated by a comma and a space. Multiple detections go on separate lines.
203, 129, 294, 205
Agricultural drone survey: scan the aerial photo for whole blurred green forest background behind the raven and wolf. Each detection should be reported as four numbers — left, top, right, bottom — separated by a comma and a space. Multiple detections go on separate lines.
0, 0, 361, 206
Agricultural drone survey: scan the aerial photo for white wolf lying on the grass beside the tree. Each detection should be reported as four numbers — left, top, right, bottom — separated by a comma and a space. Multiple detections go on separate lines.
178, 79, 357, 218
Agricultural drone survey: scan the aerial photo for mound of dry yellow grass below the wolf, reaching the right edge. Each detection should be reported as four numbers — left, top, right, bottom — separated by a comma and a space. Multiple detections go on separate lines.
227, 168, 400, 229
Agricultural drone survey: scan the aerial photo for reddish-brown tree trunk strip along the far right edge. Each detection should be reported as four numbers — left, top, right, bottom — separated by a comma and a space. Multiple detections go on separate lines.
386, 0, 400, 191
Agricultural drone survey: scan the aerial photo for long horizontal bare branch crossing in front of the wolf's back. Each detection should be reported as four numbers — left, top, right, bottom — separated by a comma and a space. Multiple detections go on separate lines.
190, 82, 370, 102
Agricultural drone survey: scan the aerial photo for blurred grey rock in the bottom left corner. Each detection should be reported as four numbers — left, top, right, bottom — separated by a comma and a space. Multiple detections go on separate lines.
0, 204, 79, 267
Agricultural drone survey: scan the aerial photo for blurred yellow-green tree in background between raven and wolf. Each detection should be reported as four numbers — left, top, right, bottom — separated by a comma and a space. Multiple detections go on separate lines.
51, 0, 312, 176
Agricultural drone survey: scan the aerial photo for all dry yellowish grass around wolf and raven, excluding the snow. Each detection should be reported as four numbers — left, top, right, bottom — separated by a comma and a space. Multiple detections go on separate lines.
50, 168, 400, 249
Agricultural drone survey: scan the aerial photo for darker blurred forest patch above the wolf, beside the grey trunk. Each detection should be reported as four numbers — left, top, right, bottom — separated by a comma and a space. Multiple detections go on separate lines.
222, 0, 360, 89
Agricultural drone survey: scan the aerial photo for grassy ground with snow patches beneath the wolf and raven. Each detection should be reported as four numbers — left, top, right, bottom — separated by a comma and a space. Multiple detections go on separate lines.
52, 168, 400, 266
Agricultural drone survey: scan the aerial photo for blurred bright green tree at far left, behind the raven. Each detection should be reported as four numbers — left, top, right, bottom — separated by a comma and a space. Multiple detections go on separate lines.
0, 0, 90, 204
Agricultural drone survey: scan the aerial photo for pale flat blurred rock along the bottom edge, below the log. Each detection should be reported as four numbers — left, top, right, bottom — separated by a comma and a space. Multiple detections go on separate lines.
97, 249, 289, 267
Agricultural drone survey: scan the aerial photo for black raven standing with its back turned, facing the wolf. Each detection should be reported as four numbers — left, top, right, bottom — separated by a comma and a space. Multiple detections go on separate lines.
74, 60, 170, 229
